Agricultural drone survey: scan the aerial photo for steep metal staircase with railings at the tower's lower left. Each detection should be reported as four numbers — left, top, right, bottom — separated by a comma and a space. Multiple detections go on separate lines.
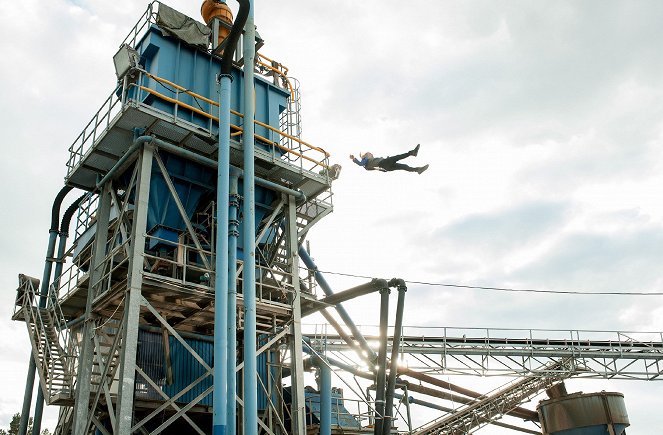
12, 274, 77, 405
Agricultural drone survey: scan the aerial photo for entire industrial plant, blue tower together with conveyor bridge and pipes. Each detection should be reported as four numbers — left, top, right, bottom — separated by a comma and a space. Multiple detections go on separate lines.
13, 0, 663, 435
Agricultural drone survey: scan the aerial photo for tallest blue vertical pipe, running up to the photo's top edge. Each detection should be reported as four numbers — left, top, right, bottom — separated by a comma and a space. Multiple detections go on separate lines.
242, 0, 258, 435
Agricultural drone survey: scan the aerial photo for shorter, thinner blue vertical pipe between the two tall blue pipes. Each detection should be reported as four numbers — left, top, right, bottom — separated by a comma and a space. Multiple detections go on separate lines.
226, 168, 239, 435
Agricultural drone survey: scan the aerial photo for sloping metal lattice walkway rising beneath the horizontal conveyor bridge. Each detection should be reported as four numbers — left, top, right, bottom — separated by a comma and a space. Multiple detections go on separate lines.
413, 358, 575, 435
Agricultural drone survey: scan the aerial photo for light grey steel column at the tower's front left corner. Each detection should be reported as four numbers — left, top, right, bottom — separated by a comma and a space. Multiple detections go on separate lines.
116, 143, 154, 434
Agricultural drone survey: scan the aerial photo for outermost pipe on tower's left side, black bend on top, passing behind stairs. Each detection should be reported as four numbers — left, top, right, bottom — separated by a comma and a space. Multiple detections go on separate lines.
18, 186, 72, 435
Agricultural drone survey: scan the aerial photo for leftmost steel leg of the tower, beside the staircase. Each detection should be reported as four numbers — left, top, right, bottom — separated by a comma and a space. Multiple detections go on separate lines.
73, 183, 111, 435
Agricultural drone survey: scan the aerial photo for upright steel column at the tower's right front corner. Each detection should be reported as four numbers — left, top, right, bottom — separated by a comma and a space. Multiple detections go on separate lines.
288, 195, 306, 435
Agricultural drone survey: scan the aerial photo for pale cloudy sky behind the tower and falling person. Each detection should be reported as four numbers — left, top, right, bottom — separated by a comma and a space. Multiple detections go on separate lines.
0, 0, 663, 435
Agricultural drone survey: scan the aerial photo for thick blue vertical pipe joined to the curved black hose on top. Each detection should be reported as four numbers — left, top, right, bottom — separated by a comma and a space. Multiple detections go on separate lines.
212, 70, 232, 435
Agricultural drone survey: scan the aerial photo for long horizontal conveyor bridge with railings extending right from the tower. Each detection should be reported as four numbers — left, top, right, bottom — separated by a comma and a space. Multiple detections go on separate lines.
303, 325, 663, 380
